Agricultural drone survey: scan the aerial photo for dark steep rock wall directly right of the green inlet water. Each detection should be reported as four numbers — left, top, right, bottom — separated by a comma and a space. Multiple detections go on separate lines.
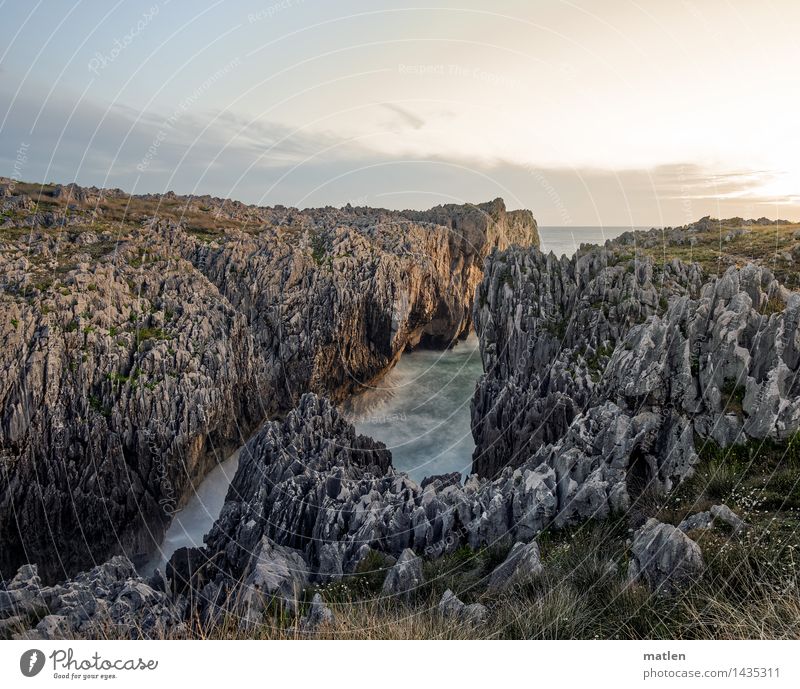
472, 249, 702, 476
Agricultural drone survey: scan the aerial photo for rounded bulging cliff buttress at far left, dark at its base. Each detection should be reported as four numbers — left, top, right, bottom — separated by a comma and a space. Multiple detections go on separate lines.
0, 233, 267, 580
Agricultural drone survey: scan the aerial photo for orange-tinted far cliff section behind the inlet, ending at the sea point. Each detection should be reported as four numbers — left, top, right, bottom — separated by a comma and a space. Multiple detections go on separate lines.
179, 199, 538, 410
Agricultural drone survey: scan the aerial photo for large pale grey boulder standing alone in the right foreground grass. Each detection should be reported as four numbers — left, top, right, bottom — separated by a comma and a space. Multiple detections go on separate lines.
628, 519, 705, 593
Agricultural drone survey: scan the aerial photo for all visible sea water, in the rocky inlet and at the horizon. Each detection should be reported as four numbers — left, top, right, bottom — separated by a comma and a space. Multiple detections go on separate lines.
140, 227, 640, 574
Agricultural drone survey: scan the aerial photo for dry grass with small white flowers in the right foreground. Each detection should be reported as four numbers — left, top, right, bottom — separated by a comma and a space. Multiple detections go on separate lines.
184, 436, 800, 639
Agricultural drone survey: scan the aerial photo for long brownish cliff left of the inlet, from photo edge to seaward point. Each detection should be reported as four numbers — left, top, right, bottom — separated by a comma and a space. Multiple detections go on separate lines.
0, 180, 536, 579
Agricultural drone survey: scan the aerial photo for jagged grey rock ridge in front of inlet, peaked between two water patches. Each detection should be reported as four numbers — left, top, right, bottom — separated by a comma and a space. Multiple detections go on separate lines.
183, 394, 712, 605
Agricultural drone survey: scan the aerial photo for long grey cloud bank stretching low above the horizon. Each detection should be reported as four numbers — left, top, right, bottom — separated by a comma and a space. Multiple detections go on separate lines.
0, 81, 800, 226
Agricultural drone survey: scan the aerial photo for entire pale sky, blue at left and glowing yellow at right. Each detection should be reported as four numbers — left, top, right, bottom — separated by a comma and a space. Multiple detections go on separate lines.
0, 0, 800, 226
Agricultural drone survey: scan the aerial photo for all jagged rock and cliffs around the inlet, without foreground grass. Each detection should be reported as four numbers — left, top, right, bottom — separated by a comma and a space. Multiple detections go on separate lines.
0, 184, 800, 638
